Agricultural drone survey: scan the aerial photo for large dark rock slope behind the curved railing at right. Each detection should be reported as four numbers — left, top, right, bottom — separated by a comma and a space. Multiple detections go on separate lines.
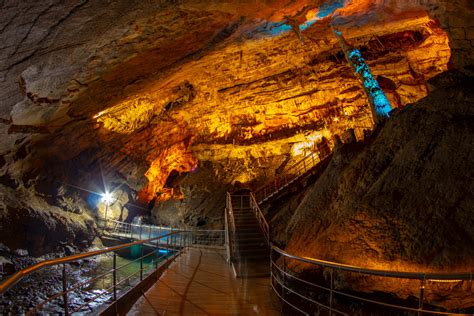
274, 71, 474, 306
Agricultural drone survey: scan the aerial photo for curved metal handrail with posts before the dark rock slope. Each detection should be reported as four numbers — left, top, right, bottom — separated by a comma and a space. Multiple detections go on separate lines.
270, 245, 473, 315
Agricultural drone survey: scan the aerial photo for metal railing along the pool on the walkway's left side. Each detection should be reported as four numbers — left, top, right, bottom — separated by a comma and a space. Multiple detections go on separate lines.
0, 226, 225, 315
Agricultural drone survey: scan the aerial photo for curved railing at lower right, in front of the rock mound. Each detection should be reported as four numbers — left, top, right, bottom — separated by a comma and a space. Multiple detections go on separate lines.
270, 245, 473, 315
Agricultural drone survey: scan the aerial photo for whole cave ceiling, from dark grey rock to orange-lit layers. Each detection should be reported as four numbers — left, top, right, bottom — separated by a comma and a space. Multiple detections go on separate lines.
0, 0, 474, 210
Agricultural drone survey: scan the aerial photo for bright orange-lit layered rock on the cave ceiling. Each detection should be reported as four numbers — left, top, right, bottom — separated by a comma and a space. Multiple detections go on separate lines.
94, 9, 451, 205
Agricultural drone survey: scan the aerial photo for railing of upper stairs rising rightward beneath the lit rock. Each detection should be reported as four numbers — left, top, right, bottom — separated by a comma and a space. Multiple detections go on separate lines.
255, 152, 329, 204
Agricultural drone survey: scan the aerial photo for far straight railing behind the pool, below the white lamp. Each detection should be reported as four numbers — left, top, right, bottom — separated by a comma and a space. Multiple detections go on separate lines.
104, 220, 226, 247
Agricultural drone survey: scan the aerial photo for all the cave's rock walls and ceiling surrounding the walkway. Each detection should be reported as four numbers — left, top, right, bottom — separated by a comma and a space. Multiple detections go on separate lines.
0, 0, 474, 315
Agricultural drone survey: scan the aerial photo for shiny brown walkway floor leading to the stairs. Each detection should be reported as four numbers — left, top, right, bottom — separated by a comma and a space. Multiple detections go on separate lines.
128, 248, 281, 316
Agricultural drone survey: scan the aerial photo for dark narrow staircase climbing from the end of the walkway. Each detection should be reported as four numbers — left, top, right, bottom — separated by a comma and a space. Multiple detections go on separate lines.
227, 194, 270, 278
